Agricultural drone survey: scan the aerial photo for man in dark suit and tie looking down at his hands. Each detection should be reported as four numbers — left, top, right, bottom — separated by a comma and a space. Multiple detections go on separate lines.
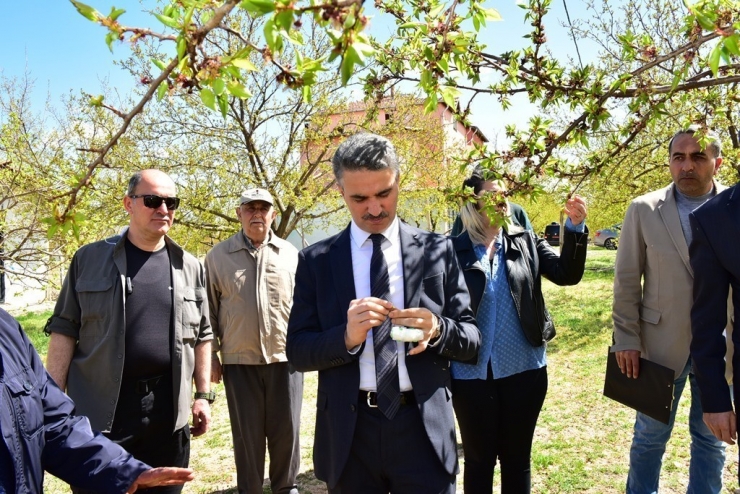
287, 133, 480, 494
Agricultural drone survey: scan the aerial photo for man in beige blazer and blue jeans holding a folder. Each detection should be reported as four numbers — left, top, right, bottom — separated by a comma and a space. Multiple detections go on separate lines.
611, 129, 725, 494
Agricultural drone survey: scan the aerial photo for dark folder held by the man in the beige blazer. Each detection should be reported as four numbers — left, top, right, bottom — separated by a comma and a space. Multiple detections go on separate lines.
604, 352, 675, 424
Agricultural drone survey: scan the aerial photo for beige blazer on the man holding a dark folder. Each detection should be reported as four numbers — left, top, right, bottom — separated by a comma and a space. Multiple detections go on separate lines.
611, 182, 732, 375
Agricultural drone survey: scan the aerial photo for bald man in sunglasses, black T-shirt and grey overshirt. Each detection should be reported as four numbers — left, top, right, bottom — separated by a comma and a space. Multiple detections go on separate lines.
45, 170, 213, 492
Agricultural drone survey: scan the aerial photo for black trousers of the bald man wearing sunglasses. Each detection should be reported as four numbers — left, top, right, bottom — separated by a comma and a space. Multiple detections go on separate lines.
72, 378, 190, 494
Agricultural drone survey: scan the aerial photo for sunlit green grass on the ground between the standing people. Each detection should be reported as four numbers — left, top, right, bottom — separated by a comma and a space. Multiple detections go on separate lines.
15, 248, 737, 494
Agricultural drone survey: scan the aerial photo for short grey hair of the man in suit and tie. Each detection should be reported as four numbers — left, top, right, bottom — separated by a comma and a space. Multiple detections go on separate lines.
331, 132, 401, 185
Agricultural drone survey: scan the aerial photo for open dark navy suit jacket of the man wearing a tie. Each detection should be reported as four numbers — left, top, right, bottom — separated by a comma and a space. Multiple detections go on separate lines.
287, 223, 480, 488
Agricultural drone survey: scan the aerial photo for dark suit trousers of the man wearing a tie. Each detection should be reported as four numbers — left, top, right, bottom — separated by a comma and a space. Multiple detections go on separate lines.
329, 400, 455, 494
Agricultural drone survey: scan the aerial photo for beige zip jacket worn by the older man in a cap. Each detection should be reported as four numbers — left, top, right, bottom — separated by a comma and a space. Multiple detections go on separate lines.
205, 230, 298, 365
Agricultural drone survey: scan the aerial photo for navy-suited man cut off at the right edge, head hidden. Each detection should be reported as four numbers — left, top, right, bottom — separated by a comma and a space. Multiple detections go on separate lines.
689, 180, 740, 466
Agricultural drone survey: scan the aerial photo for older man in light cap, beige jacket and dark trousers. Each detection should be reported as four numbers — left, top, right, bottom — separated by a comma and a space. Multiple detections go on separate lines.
205, 189, 303, 494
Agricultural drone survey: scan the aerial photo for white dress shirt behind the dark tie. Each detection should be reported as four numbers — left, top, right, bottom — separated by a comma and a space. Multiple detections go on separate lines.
350, 216, 411, 391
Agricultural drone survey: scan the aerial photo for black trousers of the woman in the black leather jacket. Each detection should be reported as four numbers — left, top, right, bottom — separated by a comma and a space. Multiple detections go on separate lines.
452, 367, 547, 494
